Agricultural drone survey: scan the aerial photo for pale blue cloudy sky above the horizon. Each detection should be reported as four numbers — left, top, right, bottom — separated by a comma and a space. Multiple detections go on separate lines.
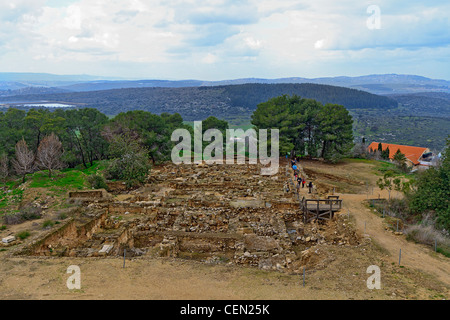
0, 0, 450, 80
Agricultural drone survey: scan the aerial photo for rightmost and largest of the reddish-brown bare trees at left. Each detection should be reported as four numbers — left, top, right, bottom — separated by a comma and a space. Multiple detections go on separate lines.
36, 133, 63, 177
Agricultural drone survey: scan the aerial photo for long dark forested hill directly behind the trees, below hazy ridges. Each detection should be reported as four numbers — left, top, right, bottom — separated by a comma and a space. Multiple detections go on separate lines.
0, 84, 398, 120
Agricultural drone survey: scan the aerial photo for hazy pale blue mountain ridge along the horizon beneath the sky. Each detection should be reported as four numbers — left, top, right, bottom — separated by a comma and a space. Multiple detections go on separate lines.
0, 73, 450, 95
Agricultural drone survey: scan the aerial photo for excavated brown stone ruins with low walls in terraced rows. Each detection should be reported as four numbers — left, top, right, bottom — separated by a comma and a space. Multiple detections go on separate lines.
14, 164, 359, 272
